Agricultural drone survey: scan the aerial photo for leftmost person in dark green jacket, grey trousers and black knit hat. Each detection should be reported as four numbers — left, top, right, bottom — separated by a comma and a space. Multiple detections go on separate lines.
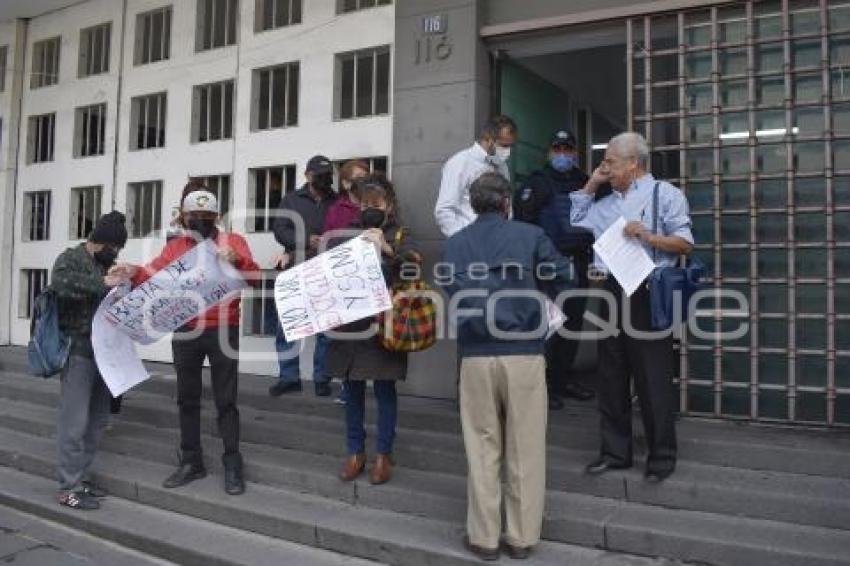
51, 211, 127, 510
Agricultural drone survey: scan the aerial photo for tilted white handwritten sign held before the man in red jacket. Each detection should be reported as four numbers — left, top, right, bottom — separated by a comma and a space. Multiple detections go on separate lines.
104, 240, 247, 344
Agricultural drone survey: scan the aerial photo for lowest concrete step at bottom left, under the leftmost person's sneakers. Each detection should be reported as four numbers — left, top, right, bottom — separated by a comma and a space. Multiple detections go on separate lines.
0, 467, 379, 566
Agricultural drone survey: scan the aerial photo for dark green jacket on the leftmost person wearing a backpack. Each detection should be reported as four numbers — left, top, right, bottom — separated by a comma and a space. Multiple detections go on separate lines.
50, 243, 109, 358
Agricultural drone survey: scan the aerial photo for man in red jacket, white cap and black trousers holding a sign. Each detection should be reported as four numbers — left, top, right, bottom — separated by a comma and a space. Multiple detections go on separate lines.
113, 190, 261, 495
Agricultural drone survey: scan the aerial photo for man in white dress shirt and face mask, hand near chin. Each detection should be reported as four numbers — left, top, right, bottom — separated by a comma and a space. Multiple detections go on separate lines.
434, 116, 517, 238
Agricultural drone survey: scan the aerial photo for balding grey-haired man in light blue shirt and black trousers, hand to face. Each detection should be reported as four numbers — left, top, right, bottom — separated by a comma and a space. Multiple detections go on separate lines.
570, 132, 694, 483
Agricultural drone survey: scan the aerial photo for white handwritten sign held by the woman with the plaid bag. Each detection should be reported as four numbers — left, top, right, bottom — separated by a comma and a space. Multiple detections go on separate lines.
274, 238, 392, 342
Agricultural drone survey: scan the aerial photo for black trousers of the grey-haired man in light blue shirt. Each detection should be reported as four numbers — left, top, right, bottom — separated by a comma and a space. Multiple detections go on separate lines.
598, 278, 677, 472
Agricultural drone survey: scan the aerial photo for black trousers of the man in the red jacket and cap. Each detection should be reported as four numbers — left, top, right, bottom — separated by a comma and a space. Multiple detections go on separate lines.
171, 326, 241, 465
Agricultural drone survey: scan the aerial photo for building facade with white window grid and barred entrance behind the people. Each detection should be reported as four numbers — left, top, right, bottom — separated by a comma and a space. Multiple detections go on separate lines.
0, 0, 850, 425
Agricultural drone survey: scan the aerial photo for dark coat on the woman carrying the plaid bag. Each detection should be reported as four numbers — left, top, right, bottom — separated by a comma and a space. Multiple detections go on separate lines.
325, 222, 414, 381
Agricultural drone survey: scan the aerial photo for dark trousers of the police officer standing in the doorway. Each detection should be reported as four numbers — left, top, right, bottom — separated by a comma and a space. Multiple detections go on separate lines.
546, 250, 590, 393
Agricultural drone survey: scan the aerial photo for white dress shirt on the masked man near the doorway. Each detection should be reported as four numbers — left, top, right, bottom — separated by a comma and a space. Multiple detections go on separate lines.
434, 142, 510, 238
